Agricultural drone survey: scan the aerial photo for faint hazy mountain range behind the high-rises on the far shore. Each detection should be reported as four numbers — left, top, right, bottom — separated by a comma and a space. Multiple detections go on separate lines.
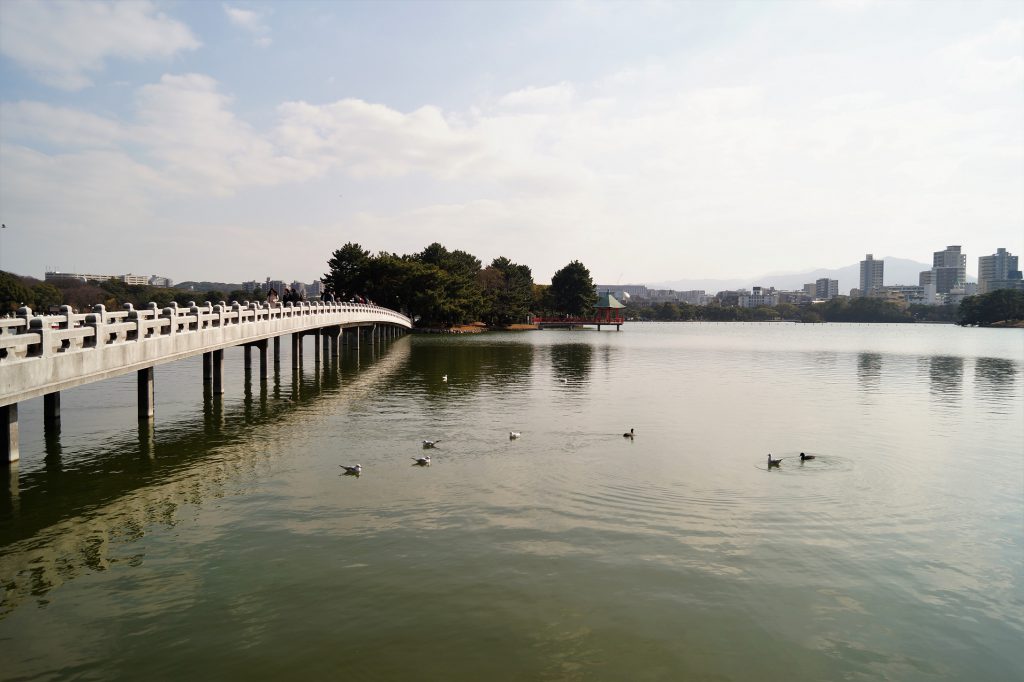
647, 256, 976, 294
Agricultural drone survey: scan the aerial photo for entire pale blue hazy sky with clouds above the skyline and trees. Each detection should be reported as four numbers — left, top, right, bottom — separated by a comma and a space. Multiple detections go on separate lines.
0, 0, 1024, 284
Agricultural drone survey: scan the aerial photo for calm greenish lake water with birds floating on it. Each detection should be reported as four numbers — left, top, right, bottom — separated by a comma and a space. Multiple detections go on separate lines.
0, 324, 1024, 682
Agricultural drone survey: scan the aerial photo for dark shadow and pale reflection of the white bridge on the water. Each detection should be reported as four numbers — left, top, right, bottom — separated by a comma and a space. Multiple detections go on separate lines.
0, 337, 410, 619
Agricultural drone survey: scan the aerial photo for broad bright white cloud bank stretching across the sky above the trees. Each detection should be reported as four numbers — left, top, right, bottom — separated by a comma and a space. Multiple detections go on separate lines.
0, 6, 1024, 279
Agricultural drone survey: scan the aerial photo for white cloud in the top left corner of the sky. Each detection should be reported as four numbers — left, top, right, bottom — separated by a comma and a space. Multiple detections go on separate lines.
0, 0, 200, 90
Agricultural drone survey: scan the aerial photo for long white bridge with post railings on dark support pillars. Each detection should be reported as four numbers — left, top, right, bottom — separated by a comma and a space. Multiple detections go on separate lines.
0, 301, 413, 465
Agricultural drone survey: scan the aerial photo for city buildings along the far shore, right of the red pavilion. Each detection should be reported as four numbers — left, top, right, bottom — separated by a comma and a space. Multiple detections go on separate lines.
596, 246, 1024, 308
